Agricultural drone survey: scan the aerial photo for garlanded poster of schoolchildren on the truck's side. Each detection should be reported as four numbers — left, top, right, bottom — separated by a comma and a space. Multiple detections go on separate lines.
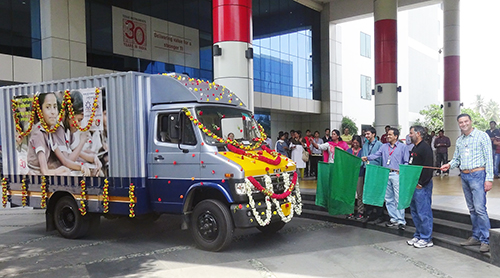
12, 88, 109, 177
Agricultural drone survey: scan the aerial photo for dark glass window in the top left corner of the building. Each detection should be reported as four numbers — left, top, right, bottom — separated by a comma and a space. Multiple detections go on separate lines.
0, 0, 42, 59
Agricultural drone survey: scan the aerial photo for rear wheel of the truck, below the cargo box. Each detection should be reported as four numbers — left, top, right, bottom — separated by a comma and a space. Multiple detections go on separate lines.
54, 196, 91, 239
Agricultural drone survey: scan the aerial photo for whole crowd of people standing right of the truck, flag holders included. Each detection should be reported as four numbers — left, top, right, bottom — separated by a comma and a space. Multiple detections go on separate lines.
275, 114, 500, 252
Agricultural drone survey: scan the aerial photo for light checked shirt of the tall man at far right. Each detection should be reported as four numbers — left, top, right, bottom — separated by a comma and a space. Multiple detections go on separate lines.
450, 128, 493, 181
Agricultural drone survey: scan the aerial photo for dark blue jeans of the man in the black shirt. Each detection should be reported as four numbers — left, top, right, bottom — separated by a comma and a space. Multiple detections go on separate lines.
410, 180, 433, 241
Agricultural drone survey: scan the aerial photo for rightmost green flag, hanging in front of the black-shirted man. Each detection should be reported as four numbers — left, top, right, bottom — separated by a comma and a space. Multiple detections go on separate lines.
398, 165, 423, 209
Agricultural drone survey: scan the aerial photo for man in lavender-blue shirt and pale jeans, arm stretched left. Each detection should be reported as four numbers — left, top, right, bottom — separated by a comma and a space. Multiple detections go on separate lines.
362, 128, 410, 230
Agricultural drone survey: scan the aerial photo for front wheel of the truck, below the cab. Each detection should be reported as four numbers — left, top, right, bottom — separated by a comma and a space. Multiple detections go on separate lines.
191, 200, 234, 252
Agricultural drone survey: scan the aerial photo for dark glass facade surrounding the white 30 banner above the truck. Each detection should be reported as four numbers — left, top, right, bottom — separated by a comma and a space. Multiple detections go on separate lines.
85, 0, 213, 80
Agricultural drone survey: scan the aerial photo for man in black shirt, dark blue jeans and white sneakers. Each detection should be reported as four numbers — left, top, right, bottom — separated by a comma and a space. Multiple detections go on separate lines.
406, 125, 434, 248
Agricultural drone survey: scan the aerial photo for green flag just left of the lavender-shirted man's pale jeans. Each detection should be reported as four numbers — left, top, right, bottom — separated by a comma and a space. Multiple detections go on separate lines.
363, 164, 390, 207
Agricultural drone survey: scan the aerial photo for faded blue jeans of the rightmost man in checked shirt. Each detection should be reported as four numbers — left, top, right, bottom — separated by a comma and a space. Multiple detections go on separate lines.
460, 170, 490, 244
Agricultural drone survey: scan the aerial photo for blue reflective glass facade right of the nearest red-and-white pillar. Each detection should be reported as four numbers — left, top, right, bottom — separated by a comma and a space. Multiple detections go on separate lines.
252, 0, 321, 100
